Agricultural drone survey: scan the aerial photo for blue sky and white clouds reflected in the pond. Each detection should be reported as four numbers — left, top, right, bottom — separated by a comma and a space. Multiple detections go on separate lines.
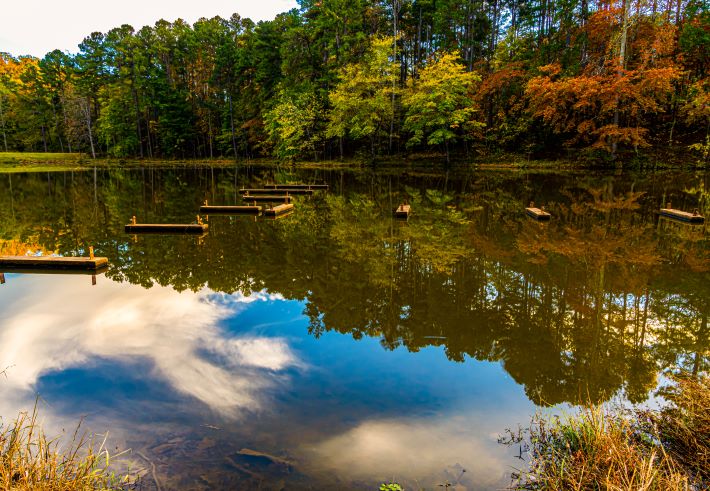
0, 275, 531, 490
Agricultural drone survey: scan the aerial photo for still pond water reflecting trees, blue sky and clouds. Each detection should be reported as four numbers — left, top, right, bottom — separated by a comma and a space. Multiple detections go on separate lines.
0, 167, 710, 491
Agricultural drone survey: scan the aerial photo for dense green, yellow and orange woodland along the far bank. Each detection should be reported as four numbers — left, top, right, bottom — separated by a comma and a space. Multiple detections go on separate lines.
0, 0, 710, 160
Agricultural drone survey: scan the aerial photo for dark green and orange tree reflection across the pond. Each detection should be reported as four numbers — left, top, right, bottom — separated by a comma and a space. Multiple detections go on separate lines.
0, 165, 710, 405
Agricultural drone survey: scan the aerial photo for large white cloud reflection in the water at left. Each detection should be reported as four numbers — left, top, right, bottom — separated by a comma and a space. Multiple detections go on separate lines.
0, 276, 301, 417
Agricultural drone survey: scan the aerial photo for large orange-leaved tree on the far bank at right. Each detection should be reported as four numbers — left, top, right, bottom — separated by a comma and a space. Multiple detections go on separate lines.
525, 2, 682, 156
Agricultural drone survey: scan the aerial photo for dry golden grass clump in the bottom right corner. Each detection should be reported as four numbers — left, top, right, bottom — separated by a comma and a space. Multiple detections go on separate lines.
503, 377, 710, 491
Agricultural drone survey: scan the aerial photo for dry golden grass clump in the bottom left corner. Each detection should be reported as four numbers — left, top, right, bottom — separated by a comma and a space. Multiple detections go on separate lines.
0, 409, 130, 491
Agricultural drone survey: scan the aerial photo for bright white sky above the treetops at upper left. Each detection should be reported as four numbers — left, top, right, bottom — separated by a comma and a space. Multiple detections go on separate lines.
0, 0, 297, 57
